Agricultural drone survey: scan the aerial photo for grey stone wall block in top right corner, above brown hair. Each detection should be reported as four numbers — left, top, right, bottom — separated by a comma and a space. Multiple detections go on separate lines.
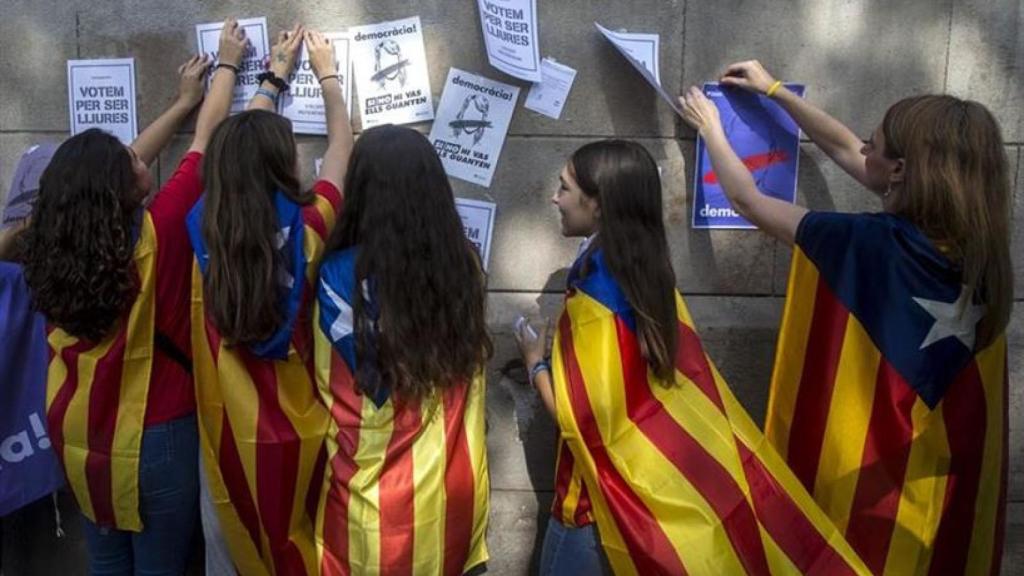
946, 0, 1024, 143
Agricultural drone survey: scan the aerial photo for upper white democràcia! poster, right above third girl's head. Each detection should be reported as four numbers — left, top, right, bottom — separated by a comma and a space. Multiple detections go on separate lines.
348, 16, 434, 129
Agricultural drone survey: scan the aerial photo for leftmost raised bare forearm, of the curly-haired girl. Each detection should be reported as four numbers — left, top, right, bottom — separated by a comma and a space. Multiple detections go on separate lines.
131, 54, 212, 165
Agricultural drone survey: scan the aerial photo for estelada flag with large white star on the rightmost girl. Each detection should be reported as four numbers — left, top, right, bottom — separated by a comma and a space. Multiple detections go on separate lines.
766, 212, 1008, 574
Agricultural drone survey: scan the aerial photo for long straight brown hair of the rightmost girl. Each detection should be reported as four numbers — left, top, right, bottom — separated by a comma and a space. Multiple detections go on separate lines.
882, 95, 1014, 349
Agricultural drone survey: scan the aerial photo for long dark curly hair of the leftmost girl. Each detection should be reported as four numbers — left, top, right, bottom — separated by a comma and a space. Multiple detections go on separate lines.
23, 128, 142, 341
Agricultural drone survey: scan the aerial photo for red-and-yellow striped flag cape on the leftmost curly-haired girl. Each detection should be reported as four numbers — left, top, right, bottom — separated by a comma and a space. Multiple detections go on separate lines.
46, 210, 157, 532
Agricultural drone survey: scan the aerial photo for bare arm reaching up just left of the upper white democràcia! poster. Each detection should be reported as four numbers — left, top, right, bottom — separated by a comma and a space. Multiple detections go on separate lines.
305, 32, 354, 193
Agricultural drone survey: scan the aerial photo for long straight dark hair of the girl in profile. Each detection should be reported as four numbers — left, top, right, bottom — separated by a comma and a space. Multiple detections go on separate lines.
569, 139, 679, 382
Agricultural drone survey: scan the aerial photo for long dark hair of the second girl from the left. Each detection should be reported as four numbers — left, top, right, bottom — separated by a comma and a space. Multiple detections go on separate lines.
202, 110, 313, 344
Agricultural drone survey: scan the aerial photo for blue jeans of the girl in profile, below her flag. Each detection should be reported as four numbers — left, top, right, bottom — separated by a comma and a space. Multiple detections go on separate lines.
540, 518, 611, 576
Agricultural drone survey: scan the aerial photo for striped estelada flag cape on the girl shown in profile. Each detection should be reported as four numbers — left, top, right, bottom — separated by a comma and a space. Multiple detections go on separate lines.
552, 250, 866, 575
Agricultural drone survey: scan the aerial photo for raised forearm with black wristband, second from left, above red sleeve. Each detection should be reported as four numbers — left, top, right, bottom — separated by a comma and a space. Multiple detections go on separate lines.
188, 18, 249, 153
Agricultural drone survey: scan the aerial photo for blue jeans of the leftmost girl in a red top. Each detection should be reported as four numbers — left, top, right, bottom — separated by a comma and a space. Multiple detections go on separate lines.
85, 414, 199, 576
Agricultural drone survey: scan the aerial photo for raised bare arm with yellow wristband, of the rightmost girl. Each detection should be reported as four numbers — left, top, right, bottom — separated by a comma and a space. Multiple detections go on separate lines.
719, 60, 867, 186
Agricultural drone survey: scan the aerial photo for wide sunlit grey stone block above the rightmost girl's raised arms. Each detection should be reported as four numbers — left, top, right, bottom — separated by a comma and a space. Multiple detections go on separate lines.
683, 0, 951, 140
